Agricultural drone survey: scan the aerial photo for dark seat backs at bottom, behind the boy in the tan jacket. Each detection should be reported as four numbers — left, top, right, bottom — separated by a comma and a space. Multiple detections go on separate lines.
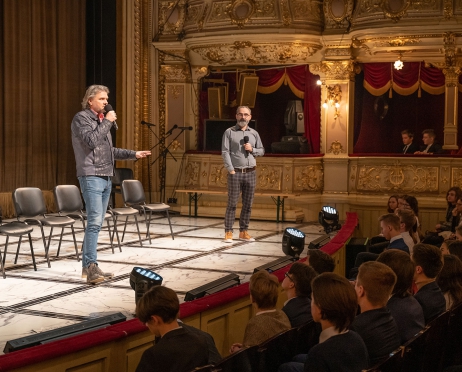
194, 321, 321, 372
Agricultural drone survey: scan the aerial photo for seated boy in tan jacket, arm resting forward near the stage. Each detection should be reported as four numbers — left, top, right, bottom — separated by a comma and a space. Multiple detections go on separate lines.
230, 270, 291, 353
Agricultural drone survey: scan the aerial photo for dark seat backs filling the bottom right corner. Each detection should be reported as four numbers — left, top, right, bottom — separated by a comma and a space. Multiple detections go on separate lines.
365, 304, 462, 372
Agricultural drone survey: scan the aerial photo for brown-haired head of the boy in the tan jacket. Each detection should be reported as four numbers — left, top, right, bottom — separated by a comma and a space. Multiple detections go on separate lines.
249, 270, 279, 310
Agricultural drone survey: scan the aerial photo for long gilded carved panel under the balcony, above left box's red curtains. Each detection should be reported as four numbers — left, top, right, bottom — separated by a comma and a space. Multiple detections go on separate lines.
191, 41, 321, 65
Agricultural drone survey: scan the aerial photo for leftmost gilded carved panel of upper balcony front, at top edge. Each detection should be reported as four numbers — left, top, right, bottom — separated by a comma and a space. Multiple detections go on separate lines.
158, 0, 187, 35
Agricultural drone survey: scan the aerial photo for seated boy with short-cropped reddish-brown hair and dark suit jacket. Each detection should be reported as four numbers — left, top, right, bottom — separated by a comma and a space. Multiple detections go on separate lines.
351, 262, 401, 366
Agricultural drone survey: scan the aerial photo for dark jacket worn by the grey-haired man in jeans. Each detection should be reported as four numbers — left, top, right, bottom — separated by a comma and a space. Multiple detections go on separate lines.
71, 109, 136, 177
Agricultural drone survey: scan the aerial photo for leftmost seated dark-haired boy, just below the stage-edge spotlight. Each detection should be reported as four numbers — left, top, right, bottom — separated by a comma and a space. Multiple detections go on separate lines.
136, 286, 209, 372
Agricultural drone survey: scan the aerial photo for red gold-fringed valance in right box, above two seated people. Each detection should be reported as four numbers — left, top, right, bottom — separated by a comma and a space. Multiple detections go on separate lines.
363, 62, 462, 96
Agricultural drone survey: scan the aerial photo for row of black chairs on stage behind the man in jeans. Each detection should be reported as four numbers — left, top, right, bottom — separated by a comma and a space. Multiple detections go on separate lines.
0, 180, 174, 278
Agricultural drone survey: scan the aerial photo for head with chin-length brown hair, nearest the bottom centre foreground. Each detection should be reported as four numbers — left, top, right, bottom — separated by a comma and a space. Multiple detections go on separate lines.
311, 273, 358, 332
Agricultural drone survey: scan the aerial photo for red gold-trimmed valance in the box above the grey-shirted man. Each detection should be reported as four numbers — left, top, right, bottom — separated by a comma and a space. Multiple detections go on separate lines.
257, 66, 306, 99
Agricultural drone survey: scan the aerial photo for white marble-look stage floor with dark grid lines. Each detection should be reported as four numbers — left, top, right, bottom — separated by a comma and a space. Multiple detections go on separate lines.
0, 215, 324, 354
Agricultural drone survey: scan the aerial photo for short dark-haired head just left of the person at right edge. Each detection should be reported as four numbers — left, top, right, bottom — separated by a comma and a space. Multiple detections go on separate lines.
411, 243, 443, 280
